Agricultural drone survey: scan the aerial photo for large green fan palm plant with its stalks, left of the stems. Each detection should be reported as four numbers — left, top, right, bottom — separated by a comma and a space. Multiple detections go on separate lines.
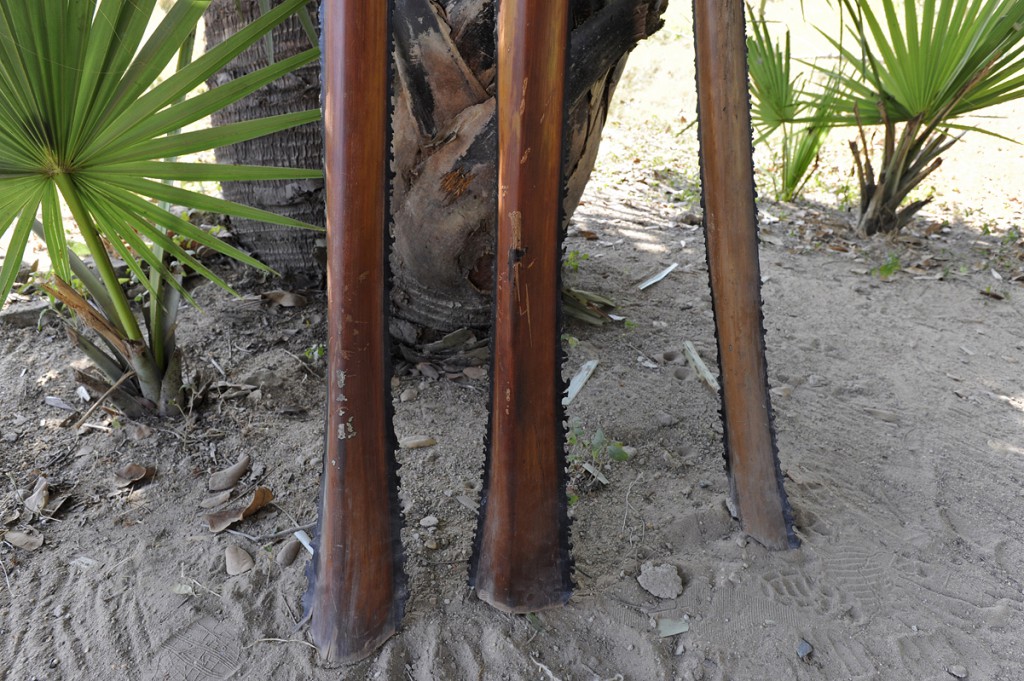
0, 0, 321, 413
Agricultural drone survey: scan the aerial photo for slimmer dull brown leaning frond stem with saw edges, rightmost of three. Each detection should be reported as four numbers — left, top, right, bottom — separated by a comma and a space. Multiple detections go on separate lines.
693, 0, 798, 549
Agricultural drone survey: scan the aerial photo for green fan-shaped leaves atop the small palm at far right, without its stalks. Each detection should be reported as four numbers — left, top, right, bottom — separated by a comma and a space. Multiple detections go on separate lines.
821, 0, 1024, 128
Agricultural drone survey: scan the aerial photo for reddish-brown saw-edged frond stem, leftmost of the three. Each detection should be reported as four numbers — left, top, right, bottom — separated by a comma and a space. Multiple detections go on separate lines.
306, 0, 406, 663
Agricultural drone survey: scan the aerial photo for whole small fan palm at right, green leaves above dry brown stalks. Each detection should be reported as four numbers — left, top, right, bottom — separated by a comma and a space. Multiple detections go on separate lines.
819, 0, 1024, 235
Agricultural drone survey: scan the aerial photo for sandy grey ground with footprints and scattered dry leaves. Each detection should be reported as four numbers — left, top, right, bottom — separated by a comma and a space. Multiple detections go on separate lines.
0, 2, 1024, 681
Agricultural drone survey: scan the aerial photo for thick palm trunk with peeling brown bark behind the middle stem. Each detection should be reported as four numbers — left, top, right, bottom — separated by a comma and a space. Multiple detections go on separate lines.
392, 0, 664, 330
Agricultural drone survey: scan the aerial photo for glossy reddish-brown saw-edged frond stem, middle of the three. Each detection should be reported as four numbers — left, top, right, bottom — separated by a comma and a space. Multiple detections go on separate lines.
470, 0, 571, 612
